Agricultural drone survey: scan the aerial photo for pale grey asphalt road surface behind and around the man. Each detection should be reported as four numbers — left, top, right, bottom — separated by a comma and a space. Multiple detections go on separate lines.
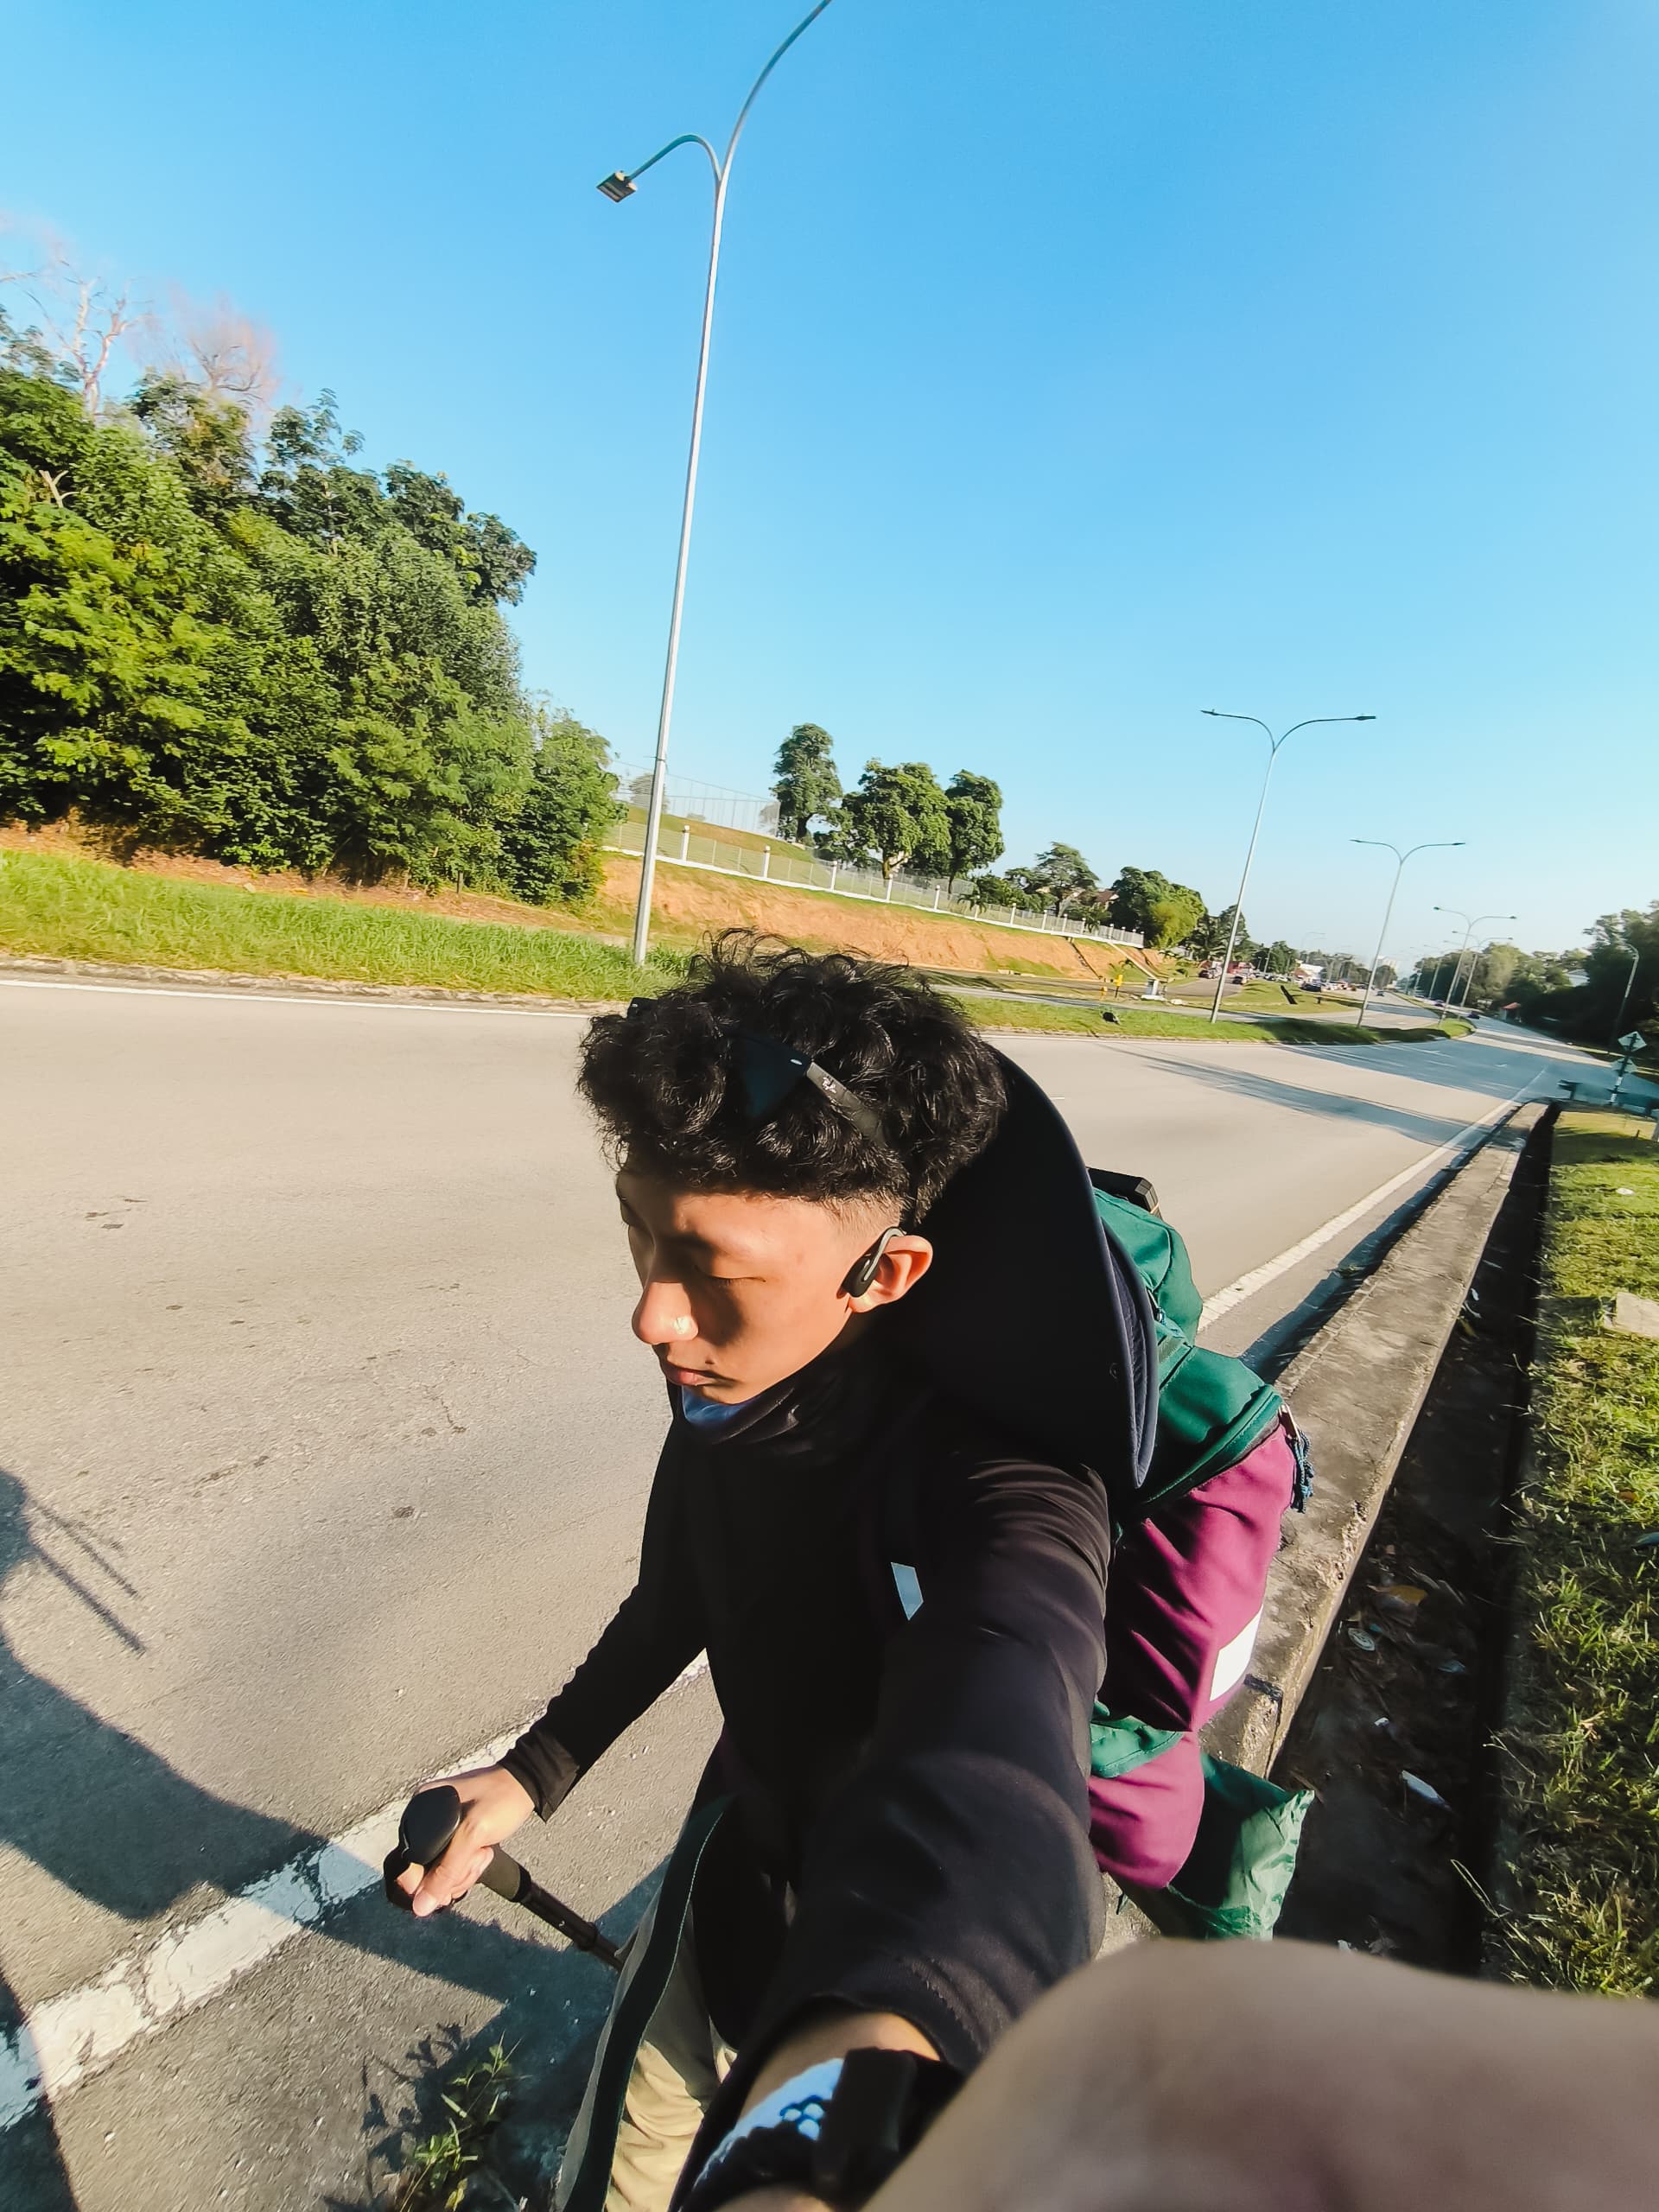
0, 980, 1610, 2212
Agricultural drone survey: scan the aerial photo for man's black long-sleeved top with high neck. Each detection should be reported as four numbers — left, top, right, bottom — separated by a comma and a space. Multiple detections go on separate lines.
505, 1332, 1110, 2073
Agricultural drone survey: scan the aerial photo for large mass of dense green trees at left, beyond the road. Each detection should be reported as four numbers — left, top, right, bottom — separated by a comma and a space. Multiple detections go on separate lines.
0, 346, 615, 898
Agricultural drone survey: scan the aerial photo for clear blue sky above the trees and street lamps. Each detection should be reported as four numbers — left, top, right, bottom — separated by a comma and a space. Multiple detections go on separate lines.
0, 0, 1659, 953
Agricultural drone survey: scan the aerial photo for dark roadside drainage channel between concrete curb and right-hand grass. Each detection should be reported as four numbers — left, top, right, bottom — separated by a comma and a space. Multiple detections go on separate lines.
1274, 1115, 1551, 1974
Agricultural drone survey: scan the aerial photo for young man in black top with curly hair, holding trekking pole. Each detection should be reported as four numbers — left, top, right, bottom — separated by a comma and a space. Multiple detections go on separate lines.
404, 938, 1154, 2212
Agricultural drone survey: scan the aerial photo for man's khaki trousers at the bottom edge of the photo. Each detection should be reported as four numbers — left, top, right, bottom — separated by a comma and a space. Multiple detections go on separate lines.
553, 1920, 732, 2212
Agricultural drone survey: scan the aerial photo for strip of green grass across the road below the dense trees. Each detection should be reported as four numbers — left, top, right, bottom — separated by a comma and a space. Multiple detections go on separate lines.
0, 852, 683, 1000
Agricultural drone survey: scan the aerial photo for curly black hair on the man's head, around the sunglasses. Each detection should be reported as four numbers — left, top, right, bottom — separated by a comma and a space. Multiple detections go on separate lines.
577, 929, 1004, 1221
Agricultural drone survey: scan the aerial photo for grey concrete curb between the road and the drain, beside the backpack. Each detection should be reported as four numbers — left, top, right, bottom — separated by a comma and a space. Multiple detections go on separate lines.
1204, 1103, 1546, 1774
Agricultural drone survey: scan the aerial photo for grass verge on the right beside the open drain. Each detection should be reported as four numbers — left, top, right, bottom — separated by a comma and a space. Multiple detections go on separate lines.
1502, 1113, 1659, 1998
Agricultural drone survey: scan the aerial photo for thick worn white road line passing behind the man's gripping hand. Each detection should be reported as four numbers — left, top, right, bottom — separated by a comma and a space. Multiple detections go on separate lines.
0, 1655, 708, 2130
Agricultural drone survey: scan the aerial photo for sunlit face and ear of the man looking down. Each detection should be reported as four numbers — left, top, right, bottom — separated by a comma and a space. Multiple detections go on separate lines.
617, 1168, 933, 1405
